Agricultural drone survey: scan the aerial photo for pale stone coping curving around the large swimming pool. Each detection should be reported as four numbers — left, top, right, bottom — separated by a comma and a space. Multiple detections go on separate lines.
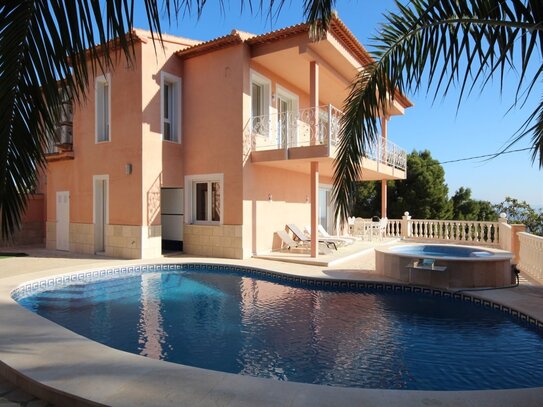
0, 258, 543, 406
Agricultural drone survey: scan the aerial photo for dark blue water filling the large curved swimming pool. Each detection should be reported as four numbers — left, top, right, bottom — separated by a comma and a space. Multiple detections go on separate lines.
15, 270, 543, 390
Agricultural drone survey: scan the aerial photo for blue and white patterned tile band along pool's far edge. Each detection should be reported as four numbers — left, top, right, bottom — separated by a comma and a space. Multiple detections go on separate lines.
11, 263, 543, 330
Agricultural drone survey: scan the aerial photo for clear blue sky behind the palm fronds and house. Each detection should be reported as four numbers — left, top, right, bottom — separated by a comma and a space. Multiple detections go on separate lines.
135, 0, 543, 207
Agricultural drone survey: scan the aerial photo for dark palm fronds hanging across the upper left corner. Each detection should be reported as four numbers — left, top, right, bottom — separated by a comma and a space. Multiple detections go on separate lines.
0, 0, 333, 238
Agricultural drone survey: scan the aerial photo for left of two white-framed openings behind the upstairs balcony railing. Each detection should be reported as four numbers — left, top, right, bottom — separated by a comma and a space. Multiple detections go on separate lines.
251, 71, 271, 135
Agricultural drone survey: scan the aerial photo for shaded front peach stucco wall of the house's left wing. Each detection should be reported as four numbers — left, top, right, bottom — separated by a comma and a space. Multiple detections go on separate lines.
47, 44, 141, 225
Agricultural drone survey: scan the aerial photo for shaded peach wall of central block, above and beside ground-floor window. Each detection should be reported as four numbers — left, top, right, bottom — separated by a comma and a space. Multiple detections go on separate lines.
183, 45, 248, 225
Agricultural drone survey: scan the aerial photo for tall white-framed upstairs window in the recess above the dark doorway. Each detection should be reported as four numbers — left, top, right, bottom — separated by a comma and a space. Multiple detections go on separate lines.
160, 72, 181, 143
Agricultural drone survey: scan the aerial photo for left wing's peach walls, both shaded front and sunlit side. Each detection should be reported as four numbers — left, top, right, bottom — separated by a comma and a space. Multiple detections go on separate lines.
47, 39, 191, 257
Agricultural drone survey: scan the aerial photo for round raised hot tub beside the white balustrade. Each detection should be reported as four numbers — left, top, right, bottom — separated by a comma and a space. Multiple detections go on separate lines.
375, 244, 514, 288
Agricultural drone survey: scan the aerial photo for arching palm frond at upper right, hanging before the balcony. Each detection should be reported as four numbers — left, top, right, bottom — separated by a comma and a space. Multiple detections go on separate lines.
332, 0, 543, 223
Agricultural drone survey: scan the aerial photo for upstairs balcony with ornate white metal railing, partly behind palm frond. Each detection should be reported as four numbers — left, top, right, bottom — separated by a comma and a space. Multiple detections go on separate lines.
245, 105, 407, 180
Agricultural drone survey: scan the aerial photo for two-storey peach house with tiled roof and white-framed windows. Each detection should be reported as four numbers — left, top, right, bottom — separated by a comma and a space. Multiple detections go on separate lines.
46, 19, 410, 258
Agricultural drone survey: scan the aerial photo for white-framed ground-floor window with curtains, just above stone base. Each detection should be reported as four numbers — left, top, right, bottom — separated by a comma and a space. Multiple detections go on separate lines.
185, 174, 224, 224
